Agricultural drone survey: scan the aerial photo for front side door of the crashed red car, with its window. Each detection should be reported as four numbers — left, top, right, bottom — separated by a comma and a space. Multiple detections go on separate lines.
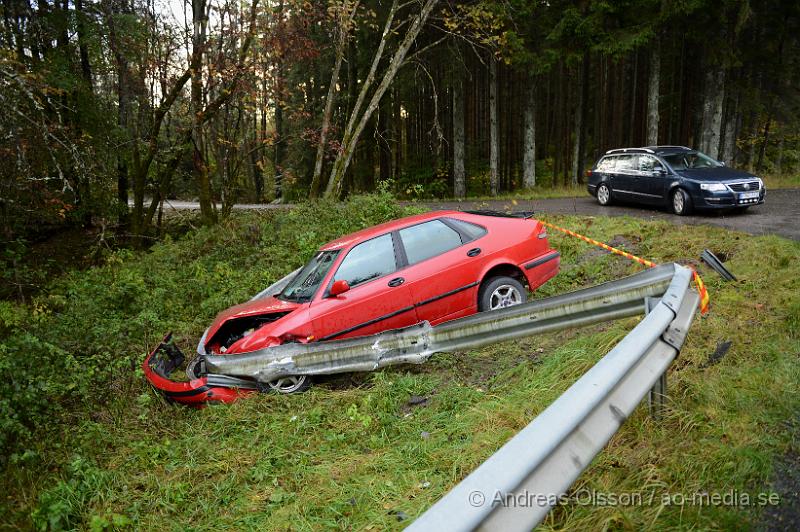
310, 233, 417, 341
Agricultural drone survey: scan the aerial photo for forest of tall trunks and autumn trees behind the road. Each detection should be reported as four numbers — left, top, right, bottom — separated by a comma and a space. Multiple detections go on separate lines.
0, 0, 800, 238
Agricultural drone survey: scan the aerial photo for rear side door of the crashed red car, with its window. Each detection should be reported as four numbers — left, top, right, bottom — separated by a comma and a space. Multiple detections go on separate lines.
398, 218, 486, 325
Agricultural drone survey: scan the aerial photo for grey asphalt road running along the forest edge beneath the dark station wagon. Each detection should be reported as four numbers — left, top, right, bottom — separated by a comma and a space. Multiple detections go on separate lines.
147, 189, 800, 241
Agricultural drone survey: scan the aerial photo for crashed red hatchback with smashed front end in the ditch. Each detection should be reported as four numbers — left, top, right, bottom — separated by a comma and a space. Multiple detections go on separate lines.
143, 211, 559, 403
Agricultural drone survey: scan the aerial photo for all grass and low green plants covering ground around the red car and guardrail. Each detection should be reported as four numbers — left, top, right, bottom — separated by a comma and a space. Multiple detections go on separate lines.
0, 195, 800, 530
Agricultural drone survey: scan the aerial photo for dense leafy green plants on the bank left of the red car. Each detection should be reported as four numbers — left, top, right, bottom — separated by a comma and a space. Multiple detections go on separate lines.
0, 190, 404, 462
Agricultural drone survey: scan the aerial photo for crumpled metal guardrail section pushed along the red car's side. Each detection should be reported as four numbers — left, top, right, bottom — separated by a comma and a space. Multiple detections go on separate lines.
203, 264, 691, 382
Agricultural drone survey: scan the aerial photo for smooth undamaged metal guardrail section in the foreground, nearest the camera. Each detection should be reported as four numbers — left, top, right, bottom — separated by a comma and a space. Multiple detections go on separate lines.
407, 265, 699, 531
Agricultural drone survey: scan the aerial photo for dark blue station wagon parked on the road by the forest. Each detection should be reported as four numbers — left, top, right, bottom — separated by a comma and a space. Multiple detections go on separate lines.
587, 146, 766, 215
